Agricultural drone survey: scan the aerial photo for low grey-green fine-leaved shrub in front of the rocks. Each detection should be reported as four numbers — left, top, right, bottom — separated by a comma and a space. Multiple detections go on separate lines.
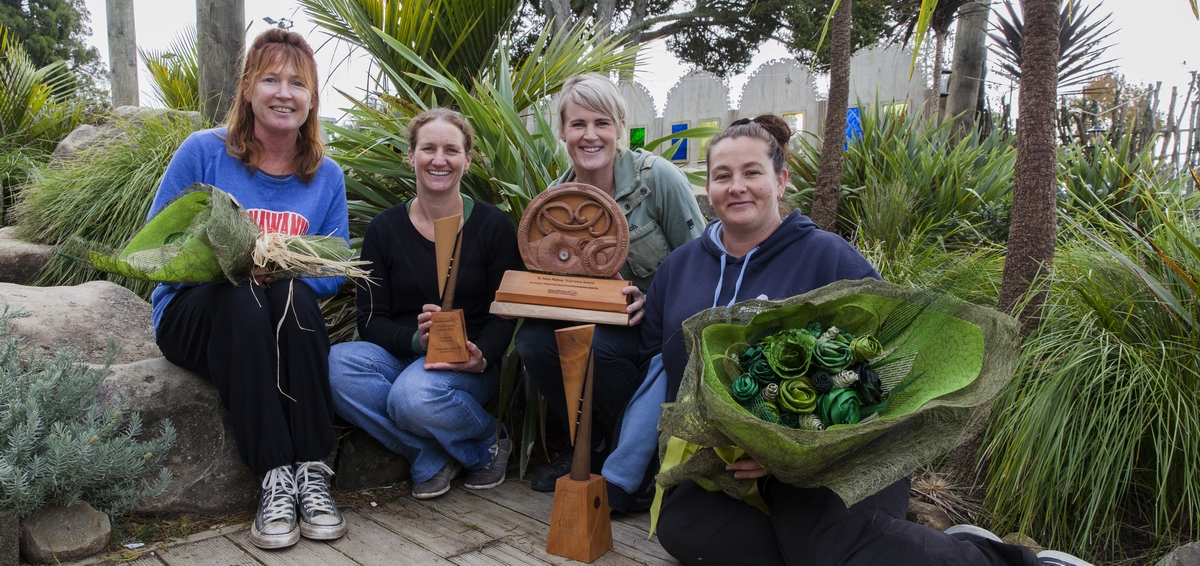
0, 307, 175, 517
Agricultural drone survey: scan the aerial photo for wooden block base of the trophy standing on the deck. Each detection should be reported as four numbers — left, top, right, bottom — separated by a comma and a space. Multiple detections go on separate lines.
546, 474, 612, 562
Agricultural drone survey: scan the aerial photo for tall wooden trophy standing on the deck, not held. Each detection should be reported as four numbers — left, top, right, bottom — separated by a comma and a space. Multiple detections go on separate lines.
546, 324, 612, 562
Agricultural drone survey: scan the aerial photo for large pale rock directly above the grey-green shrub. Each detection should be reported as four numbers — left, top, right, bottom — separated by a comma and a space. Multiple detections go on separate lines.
0, 281, 162, 363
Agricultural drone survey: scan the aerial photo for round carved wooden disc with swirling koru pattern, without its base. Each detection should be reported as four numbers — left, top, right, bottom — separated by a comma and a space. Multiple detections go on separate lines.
517, 182, 629, 277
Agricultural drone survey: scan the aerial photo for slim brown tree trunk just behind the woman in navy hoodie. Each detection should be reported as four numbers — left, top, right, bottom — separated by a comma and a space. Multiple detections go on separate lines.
810, 0, 853, 231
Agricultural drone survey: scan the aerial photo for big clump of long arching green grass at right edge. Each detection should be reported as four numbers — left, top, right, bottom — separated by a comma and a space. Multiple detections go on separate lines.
985, 194, 1200, 560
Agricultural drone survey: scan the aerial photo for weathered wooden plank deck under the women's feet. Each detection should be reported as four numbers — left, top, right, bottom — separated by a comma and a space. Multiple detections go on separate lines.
78, 480, 678, 566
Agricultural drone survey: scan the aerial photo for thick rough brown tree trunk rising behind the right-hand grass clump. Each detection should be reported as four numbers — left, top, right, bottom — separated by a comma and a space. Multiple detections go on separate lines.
998, 0, 1058, 337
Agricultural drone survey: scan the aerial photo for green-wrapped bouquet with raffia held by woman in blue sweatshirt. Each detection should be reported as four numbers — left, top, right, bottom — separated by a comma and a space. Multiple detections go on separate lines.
88, 183, 366, 284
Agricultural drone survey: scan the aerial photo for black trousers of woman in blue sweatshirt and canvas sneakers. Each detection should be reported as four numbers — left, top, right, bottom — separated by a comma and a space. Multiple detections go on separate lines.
157, 279, 335, 476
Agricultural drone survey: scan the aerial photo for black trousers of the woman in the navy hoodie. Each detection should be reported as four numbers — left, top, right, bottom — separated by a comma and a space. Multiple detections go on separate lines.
658, 478, 1037, 566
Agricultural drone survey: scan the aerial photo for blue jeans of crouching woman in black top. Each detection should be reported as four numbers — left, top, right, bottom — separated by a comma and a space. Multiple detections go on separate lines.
329, 342, 499, 482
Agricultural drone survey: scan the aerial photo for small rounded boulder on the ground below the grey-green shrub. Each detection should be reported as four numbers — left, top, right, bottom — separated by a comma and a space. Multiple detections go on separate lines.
20, 502, 113, 564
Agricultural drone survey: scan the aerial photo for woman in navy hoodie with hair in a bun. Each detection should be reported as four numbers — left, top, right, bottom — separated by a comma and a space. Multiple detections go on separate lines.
641, 115, 1085, 566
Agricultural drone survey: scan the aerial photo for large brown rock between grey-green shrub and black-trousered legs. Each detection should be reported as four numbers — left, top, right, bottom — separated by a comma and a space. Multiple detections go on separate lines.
100, 357, 259, 514
